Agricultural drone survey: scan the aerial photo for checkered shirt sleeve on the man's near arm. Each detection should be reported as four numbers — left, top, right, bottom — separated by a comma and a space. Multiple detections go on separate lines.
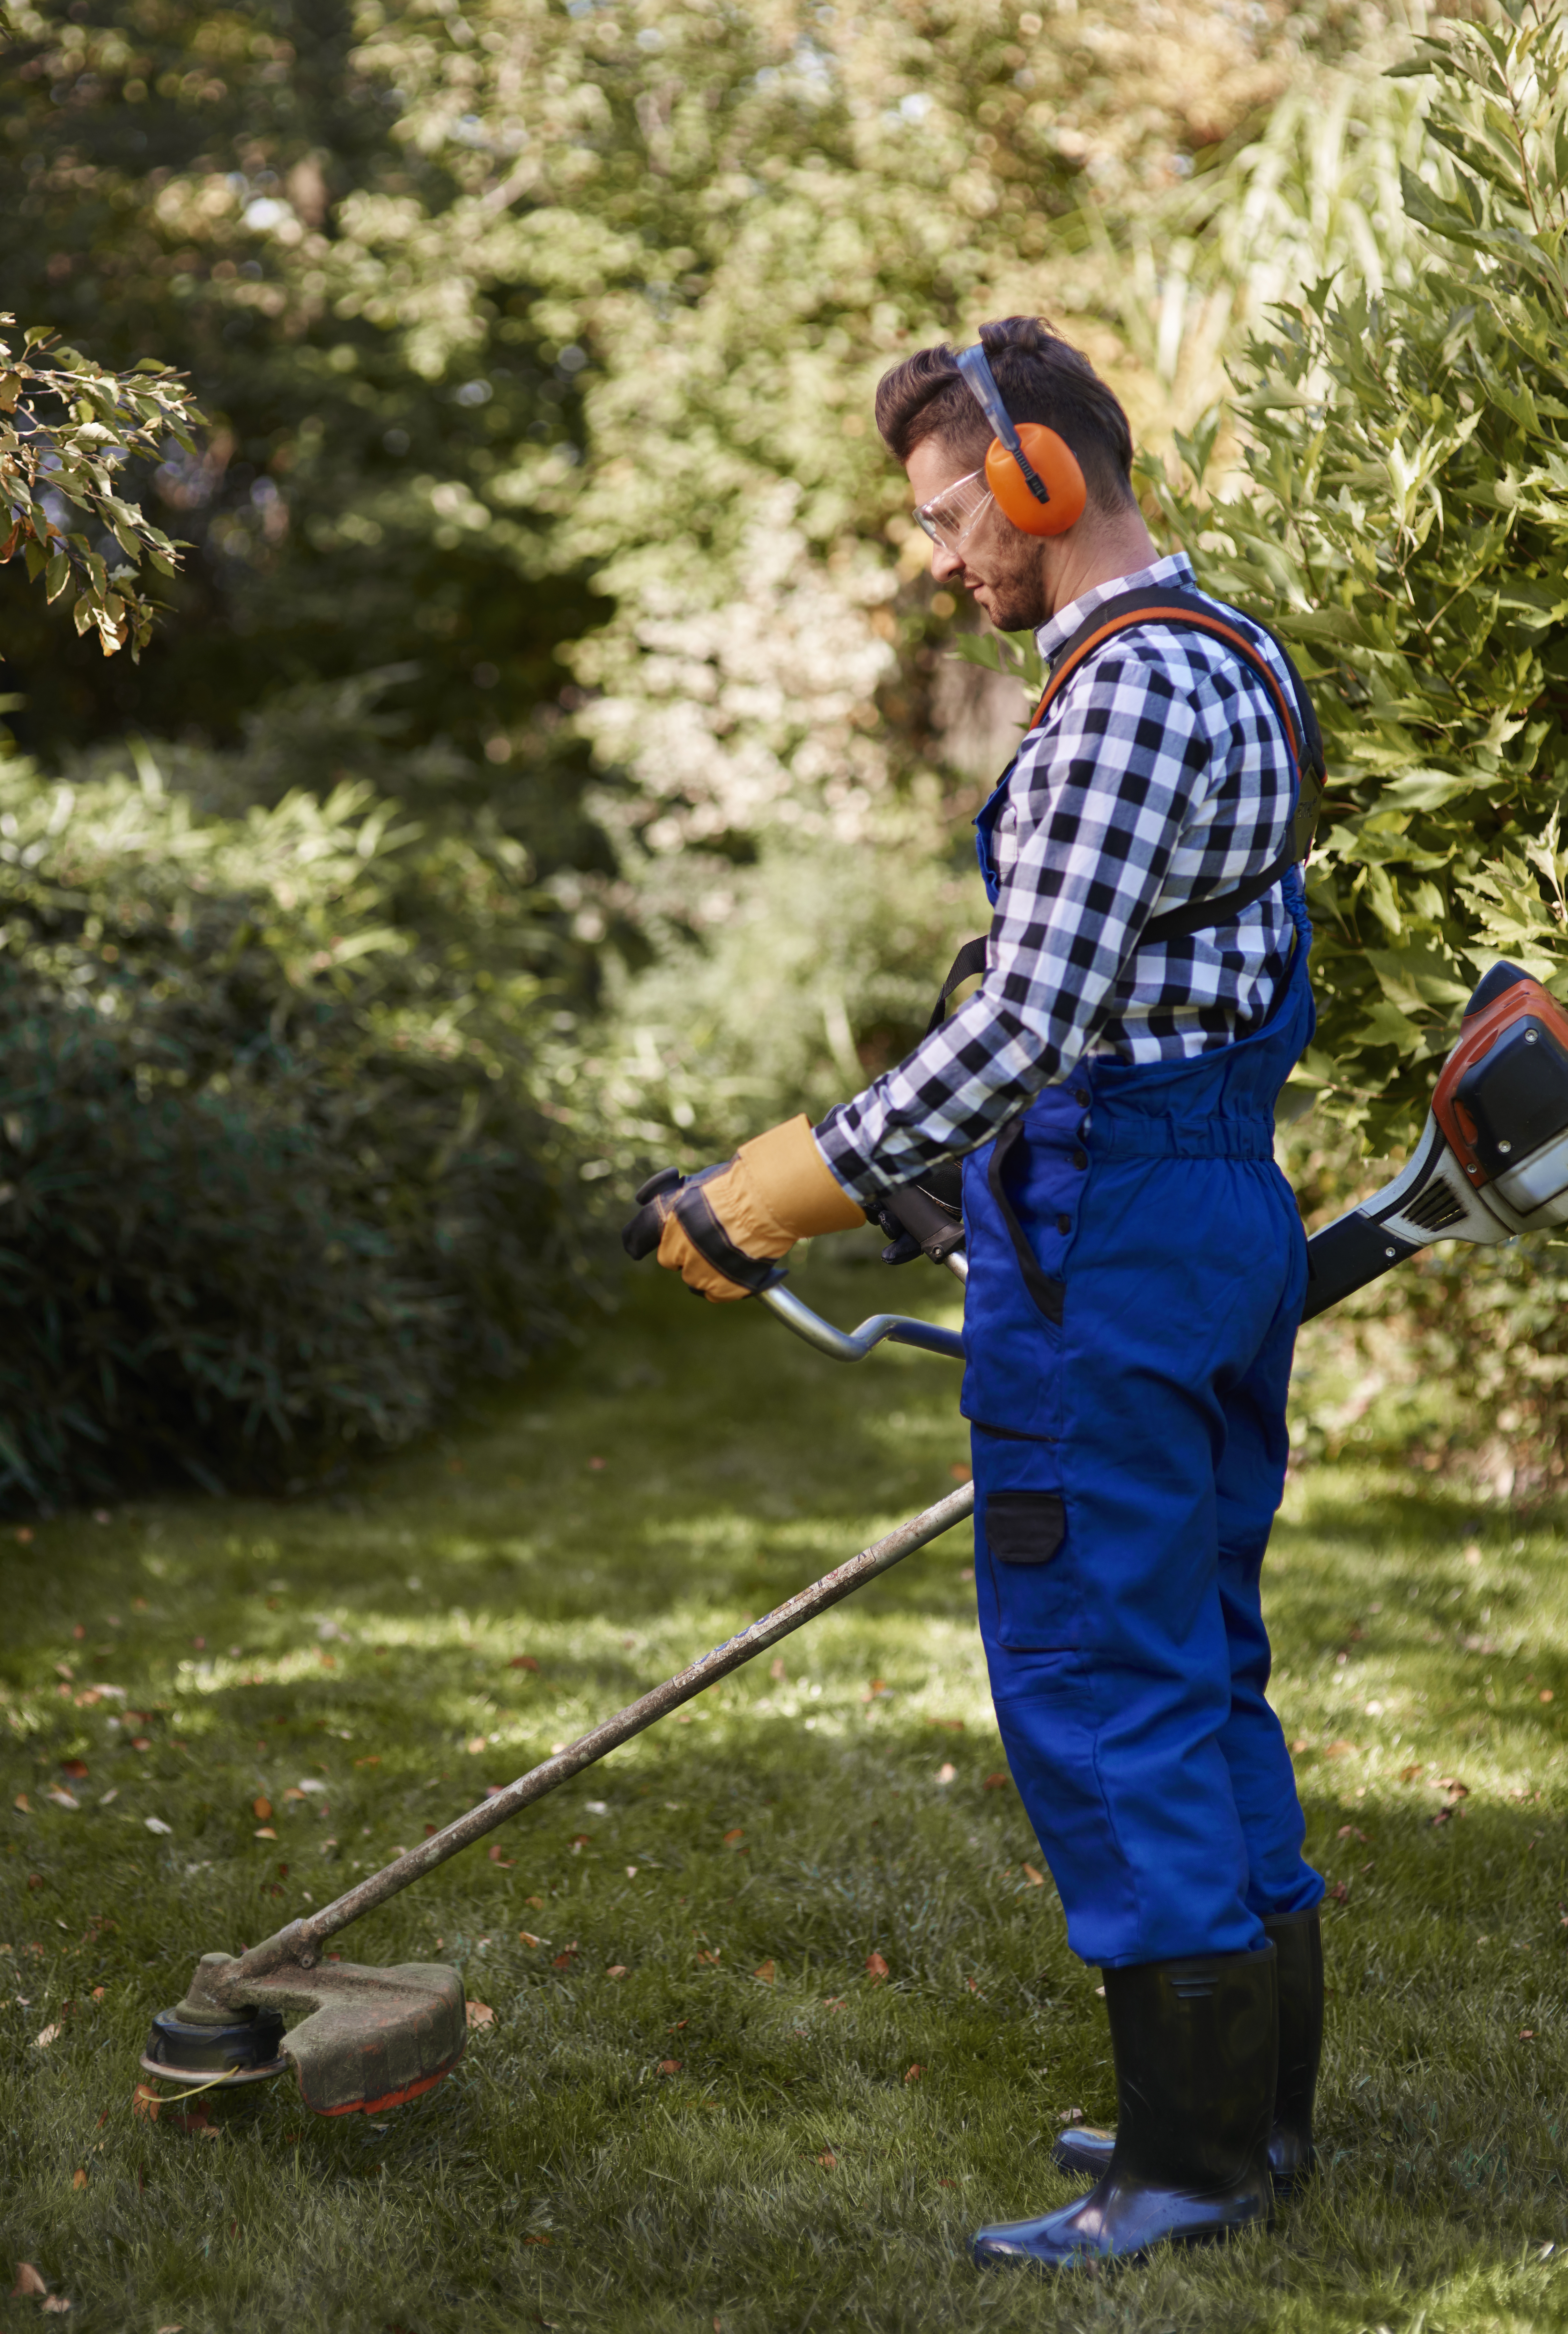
814, 647, 1218, 1202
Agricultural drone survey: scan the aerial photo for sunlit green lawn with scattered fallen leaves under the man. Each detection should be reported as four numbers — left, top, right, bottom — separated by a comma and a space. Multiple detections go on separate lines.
0, 1260, 1568, 2334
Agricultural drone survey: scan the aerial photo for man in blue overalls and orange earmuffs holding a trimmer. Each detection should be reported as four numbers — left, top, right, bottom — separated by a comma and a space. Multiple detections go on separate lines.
628, 317, 1323, 2264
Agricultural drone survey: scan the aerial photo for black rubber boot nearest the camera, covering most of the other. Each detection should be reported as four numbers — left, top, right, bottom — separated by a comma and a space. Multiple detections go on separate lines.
973, 1947, 1279, 2269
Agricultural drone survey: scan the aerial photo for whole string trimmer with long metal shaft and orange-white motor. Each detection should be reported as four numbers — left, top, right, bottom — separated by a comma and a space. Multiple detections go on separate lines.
142, 964, 1568, 2115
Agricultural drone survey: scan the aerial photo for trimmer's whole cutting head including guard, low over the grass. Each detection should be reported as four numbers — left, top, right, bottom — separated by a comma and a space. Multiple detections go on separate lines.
142, 1953, 469, 2115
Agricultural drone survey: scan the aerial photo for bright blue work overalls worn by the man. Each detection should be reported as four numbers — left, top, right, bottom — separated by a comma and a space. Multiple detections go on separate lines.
961, 798, 1323, 1967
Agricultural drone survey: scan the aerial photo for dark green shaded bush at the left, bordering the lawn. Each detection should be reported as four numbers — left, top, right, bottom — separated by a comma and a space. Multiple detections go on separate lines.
0, 749, 583, 1503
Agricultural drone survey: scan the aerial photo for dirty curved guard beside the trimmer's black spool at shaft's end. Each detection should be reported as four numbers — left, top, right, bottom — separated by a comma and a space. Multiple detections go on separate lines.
203, 1953, 469, 2115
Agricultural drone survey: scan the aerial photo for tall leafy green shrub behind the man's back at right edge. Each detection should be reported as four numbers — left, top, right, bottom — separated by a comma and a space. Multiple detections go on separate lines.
1150, 5, 1568, 1151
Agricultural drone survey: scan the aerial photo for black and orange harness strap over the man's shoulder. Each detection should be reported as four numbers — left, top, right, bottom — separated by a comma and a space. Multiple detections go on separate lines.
926, 584, 1325, 1036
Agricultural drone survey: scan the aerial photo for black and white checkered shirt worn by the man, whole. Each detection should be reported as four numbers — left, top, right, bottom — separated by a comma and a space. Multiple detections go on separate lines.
814, 555, 1293, 1200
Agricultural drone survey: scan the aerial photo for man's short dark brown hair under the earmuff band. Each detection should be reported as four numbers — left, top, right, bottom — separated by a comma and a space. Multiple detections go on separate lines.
877, 315, 1136, 514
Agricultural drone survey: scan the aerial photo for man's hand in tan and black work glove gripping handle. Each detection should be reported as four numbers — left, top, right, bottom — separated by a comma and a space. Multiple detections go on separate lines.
621, 1113, 866, 1305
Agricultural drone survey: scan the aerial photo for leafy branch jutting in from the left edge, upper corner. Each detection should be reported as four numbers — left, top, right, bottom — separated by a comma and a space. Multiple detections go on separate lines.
0, 315, 205, 658
